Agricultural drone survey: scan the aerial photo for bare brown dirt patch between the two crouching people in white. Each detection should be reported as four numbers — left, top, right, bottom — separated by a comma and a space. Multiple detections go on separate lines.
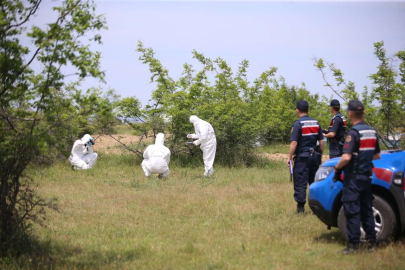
93, 134, 154, 154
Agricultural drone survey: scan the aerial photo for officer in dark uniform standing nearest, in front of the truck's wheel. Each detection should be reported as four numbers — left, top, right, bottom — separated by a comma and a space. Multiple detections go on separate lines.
335, 100, 381, 254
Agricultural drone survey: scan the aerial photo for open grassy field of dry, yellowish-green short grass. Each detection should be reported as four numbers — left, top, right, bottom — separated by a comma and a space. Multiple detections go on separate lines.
0, 151, 405, 269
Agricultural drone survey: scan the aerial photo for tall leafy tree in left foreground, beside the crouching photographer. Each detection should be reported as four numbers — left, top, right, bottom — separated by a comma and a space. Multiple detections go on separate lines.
0, 0, 113, 254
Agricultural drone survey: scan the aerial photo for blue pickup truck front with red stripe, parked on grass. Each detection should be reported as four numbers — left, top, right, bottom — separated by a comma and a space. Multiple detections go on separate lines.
308, 150, 405, 242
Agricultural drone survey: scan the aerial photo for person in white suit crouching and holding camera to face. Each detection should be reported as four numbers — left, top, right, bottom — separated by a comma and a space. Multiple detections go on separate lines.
69, 134, 98, 170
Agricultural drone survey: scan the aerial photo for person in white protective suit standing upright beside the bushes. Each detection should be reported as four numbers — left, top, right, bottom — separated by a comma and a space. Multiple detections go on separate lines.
187, 115, 217, 177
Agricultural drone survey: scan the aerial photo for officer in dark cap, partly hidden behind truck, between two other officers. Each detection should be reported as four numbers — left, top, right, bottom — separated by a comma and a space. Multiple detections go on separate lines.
322, 99, 346, 159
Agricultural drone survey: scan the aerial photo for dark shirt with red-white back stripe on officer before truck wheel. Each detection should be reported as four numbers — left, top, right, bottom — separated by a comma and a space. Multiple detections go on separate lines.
343, 122, 380, 176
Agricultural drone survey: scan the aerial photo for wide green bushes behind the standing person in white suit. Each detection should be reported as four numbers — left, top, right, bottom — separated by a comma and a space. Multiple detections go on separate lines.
119, 42, 327, 165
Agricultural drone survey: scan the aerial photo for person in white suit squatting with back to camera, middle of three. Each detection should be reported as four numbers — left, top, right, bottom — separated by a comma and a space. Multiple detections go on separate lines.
142, 133, 170, 178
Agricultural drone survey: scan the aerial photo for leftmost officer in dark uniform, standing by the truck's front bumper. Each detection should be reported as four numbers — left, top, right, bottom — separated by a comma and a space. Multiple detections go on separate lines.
287, 100, 325, 213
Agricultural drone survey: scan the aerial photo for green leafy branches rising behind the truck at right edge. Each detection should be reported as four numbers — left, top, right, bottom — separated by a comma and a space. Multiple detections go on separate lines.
314, 41, 405, 148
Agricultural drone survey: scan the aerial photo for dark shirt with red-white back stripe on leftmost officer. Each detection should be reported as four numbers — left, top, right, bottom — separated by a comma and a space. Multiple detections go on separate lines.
290, 115, 323, 156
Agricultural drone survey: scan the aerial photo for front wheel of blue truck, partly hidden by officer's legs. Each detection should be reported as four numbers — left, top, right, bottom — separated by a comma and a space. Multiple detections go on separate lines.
338, 195, 397, 242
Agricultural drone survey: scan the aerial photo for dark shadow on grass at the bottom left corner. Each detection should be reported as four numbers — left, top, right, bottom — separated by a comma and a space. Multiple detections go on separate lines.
0, 236, 152, 269
